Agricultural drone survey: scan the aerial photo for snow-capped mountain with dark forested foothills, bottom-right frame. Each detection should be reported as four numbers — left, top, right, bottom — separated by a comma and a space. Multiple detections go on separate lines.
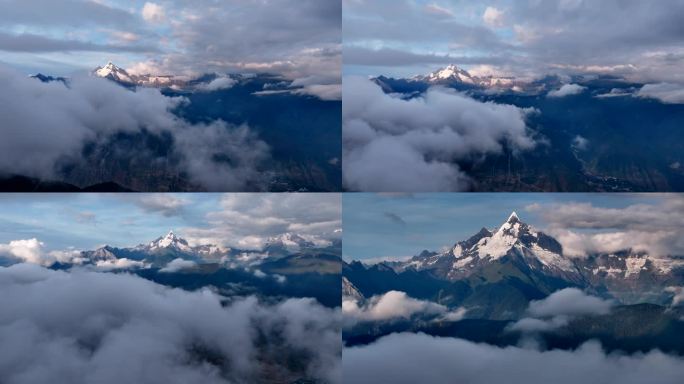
342, 212, 684, 355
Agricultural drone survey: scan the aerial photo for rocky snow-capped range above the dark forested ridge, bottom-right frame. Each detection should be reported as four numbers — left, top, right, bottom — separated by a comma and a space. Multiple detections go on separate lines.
343, 212, 684, 320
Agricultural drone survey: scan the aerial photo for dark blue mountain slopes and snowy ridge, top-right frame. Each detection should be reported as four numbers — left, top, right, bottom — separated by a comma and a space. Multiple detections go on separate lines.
372, 65, 684, 192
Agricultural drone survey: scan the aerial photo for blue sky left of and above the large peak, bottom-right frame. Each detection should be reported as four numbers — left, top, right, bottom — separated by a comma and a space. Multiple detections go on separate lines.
343, 193, 672, 260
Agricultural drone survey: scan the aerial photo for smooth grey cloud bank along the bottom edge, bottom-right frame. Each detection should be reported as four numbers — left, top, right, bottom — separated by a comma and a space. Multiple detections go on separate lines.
342, 334, 684, 384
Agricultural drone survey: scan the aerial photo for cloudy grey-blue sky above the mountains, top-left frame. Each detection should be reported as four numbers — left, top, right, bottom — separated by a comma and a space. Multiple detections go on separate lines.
0, 0, 342, 88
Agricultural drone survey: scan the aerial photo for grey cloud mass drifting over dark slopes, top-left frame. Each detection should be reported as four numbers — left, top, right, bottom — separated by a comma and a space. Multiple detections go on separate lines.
0, 66, 269, 190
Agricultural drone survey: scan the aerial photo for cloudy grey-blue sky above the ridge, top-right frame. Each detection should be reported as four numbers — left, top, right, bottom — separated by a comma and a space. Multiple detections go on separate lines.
343, 0, 684, 84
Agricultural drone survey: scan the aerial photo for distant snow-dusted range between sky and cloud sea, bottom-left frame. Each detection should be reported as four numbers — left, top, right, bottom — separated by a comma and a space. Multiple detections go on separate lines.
34, 231, 342, 307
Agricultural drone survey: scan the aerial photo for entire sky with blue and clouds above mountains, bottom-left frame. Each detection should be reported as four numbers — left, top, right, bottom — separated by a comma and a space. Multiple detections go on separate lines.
0, 193, 341, 251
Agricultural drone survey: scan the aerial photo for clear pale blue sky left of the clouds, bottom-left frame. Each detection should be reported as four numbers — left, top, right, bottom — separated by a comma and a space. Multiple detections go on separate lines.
0, 194, 220, 250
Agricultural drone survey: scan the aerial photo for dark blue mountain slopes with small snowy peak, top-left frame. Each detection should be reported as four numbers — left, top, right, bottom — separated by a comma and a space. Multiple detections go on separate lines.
0, 62, 342, 192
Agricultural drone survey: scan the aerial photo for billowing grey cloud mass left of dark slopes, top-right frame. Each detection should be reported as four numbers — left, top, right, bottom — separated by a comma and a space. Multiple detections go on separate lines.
342, 76, 536, 192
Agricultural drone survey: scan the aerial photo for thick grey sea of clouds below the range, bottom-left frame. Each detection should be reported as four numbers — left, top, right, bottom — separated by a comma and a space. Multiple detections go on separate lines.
0, 264, 341, 384
